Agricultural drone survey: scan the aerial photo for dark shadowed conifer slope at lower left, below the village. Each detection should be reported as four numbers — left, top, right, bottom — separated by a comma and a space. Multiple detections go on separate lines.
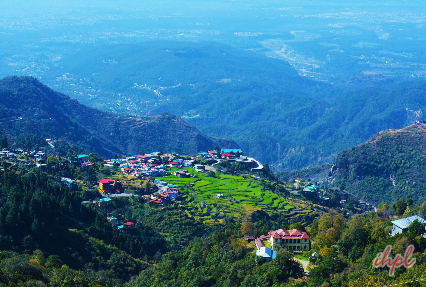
0, 162, 167, 282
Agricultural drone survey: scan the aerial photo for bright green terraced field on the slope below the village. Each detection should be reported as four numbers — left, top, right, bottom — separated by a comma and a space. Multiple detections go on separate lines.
155, 168, 302, 227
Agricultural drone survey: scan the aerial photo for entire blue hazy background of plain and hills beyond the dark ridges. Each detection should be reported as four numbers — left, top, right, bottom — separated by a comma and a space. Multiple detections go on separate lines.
0, 1, 426, 170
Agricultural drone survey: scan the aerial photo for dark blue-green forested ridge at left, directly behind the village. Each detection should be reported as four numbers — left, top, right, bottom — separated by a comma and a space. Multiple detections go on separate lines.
0, 76, 238, 157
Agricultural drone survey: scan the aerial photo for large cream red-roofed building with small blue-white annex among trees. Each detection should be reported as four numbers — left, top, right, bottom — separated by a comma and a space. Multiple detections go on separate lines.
245, 229, 311, 261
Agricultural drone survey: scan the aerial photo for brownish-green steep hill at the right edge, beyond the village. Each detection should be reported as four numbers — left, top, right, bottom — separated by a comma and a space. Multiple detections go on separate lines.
332, 123, 426, 204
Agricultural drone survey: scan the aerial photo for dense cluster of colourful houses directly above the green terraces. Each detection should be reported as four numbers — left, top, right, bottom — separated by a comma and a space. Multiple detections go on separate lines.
94, 149, 263, 217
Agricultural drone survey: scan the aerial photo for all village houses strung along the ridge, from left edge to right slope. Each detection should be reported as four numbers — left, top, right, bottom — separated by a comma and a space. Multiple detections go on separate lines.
0, 146, 374, 220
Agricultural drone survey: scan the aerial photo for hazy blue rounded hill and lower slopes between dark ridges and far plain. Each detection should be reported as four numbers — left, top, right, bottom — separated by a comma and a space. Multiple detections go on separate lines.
43, 41, 426, 170
